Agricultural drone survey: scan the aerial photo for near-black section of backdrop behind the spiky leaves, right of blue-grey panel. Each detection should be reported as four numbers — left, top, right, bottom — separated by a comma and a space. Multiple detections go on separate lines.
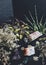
13, 0, 46, 19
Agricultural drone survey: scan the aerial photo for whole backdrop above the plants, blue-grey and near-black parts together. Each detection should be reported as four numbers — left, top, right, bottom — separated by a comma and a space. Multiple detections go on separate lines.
0, 0, 46, 20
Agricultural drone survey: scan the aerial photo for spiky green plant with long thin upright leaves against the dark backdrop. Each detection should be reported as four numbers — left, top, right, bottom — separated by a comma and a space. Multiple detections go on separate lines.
25, 5, 46, 34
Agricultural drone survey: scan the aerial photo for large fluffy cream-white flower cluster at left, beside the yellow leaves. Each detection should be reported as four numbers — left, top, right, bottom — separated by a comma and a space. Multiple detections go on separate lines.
0, 24, 19, 49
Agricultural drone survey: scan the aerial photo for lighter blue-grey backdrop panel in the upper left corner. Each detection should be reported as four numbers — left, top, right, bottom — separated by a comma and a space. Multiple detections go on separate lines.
0, 0, 13, 21
